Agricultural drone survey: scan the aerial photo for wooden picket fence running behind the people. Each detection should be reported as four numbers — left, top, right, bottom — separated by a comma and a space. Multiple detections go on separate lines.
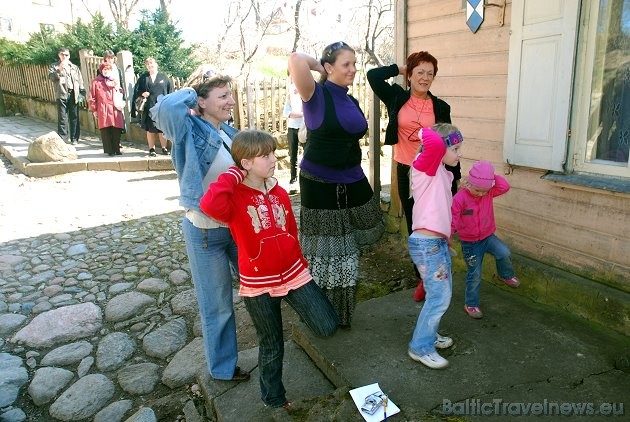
0, 54, 386, 133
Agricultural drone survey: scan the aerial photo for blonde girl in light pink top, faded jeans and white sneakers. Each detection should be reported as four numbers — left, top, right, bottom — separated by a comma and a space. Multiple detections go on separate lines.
407, 123, 463, 369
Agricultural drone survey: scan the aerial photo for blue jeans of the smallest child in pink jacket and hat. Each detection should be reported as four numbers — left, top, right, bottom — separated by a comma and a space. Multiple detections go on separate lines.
461, 234, 514, 306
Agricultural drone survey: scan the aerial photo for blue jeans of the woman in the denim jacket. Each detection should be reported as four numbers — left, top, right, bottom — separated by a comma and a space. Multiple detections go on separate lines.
182, 217, 243, 380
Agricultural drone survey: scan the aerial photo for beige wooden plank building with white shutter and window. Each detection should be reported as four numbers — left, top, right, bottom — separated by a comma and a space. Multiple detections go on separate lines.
395, 0, 630, 334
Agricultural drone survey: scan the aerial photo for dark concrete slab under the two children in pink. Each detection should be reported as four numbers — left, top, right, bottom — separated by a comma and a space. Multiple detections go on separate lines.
293, 274, 630, 420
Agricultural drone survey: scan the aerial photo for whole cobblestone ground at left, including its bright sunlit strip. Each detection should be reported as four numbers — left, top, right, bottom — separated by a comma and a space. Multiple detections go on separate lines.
0, 157, 282, 422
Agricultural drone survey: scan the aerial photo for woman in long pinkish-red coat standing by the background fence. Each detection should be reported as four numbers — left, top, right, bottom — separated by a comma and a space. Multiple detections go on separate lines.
88, 62, 124, 157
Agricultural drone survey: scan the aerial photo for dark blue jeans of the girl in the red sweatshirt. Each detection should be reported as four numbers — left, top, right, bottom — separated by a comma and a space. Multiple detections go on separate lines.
243, 280, 339, 407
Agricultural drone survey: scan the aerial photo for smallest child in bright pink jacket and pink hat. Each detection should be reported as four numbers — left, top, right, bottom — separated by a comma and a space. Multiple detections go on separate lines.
452, 161, 521, 318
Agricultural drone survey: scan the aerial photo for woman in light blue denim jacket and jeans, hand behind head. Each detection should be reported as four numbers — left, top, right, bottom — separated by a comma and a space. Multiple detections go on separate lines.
150, 76, 249, 381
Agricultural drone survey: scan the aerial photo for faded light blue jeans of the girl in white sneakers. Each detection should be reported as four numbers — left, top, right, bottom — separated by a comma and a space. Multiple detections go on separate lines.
409, 233, 453, 356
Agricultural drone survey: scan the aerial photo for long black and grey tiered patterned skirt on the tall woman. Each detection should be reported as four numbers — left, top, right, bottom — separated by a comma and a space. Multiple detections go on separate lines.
300, 170, 385, 326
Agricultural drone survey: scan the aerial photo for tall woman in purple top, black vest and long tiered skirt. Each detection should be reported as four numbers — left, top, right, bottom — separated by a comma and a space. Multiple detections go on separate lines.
289, 41, 385, 327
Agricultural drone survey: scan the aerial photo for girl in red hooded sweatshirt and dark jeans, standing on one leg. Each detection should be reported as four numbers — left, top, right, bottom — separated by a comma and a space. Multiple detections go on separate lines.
199, 130, 339, 408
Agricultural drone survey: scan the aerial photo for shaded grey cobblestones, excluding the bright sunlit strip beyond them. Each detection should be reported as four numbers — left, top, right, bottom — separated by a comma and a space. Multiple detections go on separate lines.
0, 206, 239, 421
